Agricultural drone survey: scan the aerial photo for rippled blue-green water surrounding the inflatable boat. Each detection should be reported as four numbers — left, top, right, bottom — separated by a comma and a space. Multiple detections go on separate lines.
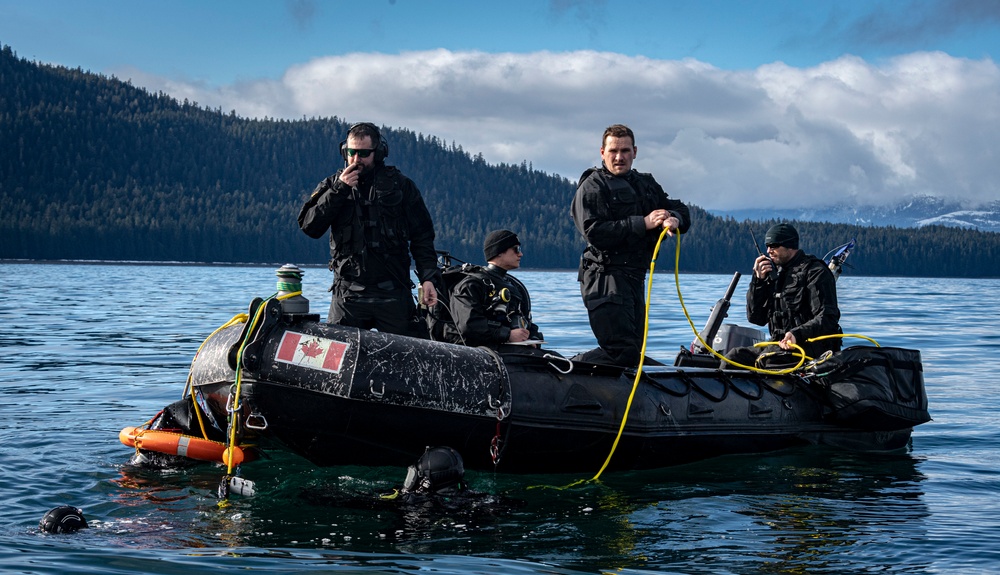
0, 264, 1000, 574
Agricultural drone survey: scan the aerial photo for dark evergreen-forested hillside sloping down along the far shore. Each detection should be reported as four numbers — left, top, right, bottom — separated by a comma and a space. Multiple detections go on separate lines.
0, 46, 1000, 277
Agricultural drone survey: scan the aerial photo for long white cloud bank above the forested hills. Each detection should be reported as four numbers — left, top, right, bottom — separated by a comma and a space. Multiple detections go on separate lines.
133, 49, 1000, 209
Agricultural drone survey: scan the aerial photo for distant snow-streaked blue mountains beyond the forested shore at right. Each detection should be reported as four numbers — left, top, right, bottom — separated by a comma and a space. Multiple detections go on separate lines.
712, 196, 1000, 232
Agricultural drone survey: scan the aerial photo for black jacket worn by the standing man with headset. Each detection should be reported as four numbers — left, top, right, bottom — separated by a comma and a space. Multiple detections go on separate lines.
298, 164, 437, 290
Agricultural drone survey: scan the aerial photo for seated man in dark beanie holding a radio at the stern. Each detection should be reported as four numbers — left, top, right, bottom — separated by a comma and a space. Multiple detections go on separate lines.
726, 224, 843, 365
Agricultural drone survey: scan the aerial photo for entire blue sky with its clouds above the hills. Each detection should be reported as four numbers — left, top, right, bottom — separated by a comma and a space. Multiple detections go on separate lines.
0, 0, 1000, 211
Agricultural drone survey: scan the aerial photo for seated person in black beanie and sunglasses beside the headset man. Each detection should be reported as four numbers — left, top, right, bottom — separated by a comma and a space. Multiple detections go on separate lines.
444, 230, 542, 349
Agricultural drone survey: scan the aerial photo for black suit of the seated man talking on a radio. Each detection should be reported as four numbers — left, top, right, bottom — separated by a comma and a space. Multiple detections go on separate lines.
747, 251, 843, 358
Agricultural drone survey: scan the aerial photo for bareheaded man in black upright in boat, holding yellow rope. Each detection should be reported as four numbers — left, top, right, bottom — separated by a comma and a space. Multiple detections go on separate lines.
572, 124, 691, 367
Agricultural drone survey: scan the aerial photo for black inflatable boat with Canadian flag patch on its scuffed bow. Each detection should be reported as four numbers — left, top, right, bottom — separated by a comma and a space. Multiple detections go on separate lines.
120, 266, 930, 473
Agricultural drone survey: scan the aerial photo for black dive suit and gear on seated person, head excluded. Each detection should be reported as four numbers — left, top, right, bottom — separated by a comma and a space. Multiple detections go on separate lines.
443, 264, 542, 348
